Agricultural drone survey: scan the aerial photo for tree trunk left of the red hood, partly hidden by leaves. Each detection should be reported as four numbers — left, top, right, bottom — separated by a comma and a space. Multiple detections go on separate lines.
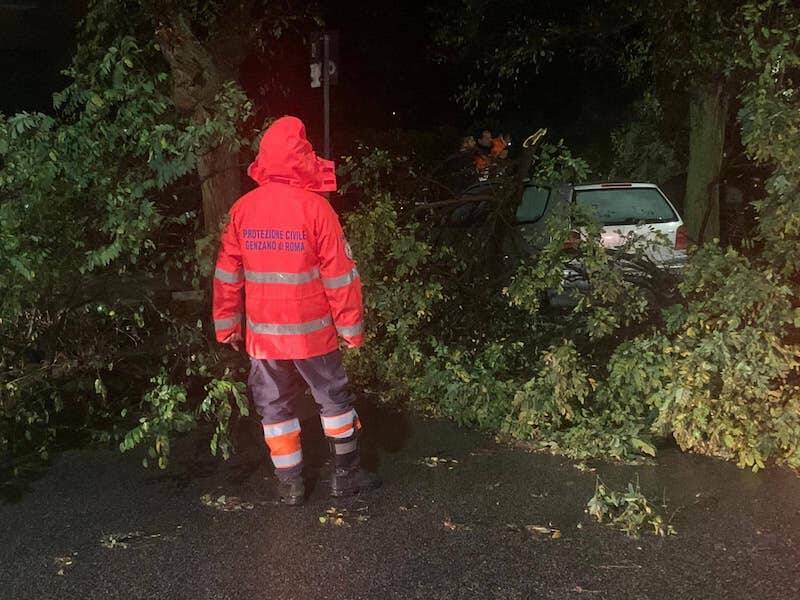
157, 14, 241, 233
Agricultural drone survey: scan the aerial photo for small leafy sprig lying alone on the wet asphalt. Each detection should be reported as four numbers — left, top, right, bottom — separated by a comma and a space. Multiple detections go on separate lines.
586, 478, 677, 538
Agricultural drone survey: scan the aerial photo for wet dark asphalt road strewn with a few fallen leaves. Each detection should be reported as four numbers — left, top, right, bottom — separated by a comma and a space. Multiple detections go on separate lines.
0, 400, 800, 600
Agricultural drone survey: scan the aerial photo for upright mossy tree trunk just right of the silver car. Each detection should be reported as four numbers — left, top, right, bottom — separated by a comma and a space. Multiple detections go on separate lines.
684, 82, 728, 243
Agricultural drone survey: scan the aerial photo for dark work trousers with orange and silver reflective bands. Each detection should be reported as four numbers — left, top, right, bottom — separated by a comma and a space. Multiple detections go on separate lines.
248, 350, 361, 480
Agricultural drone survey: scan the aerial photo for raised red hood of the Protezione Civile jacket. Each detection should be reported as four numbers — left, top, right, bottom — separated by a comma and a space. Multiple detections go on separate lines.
247, 117, 336, 192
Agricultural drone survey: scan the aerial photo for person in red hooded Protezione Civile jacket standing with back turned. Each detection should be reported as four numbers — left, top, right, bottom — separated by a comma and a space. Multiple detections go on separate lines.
213, 117, 380, 505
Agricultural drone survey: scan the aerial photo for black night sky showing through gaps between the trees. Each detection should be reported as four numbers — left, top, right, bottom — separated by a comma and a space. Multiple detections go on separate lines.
0, 0, 633, 163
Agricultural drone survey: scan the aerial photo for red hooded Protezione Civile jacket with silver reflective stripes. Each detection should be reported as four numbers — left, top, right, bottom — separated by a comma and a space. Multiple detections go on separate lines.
213, 117, 364, 359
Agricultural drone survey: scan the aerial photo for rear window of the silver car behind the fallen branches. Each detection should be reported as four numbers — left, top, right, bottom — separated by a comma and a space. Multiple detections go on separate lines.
575, 187, 678, 225
